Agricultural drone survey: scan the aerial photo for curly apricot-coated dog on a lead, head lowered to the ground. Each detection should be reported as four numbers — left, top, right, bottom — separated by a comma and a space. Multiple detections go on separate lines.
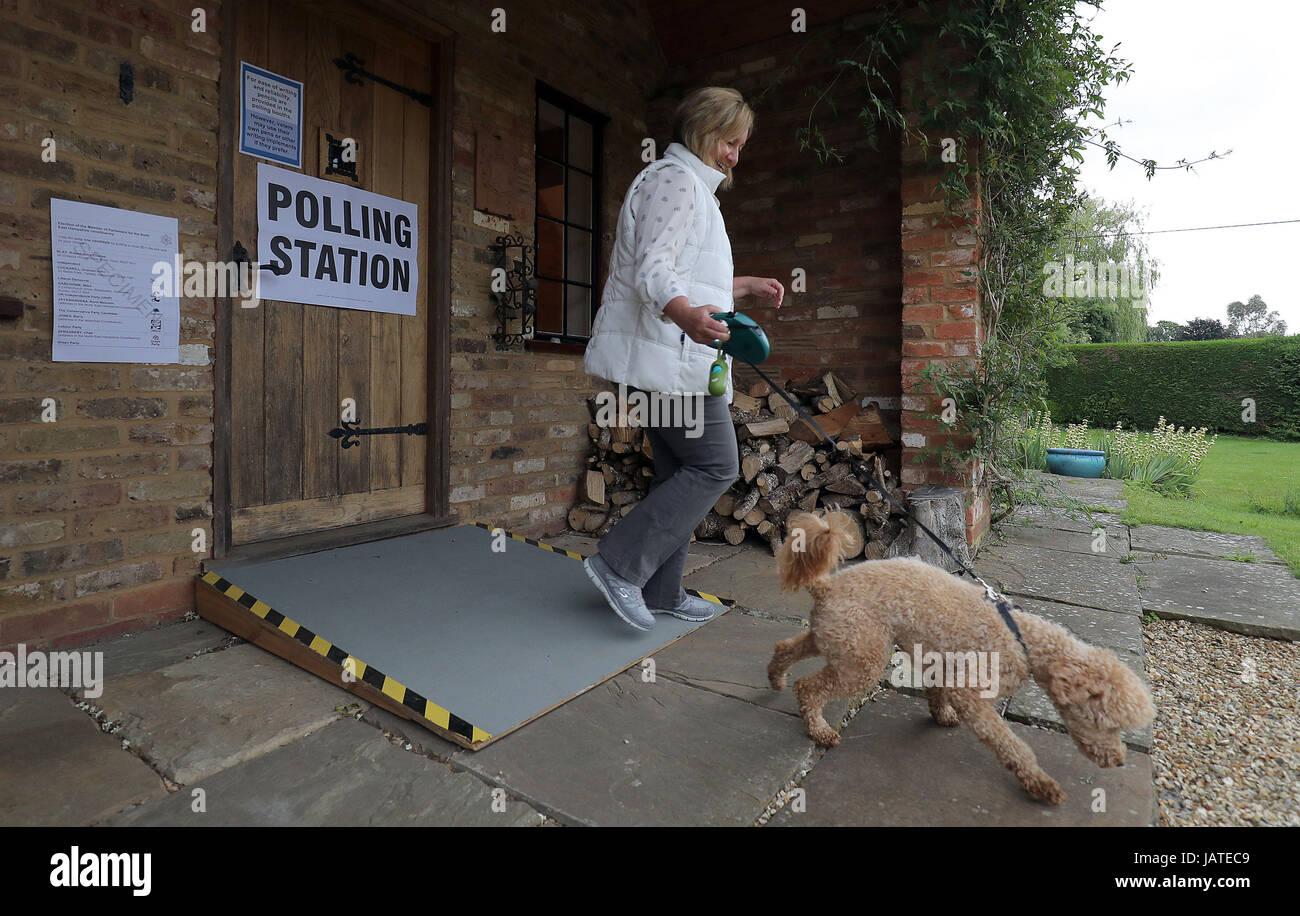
767, 512, 1156, 804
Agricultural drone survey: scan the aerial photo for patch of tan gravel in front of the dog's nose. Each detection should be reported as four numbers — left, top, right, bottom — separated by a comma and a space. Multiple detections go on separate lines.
1143, 620, 1300, 826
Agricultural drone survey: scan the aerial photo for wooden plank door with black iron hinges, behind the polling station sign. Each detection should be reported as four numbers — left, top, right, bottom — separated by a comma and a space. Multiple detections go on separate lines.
224, 0, 434, 546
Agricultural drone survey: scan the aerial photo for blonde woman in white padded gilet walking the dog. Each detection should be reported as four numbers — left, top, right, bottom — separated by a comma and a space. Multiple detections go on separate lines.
582, 87, 785, 630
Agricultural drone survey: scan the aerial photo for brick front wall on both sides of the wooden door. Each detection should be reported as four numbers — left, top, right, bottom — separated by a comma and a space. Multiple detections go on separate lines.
0, 0, 663, 647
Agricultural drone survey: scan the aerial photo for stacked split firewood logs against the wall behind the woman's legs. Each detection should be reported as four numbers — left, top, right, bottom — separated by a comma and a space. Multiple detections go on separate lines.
568, 372, 904, 559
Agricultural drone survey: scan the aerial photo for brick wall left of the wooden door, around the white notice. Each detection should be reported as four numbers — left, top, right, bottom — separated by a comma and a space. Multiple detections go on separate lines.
0, 0, 221, 646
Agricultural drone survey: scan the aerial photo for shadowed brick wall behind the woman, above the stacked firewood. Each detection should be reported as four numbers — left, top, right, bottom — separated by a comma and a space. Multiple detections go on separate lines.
651, 16, 902, 459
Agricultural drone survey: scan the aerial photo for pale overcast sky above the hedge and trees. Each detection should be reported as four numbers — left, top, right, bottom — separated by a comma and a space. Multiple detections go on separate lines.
1080, 0, 1300, 334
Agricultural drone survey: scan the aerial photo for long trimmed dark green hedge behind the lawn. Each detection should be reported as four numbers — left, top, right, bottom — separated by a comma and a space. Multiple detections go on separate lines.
1048, 335, 1300, 439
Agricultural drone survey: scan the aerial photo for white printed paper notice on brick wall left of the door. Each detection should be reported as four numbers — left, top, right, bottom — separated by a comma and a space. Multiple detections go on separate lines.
49, 197, 181, 363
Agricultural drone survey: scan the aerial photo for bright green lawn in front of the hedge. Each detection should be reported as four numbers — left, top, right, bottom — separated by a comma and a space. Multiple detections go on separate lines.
1125, 435, 1300, 577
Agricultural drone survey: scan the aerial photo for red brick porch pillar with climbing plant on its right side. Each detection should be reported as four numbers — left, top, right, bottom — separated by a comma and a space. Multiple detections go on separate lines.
900, 57, 989, 547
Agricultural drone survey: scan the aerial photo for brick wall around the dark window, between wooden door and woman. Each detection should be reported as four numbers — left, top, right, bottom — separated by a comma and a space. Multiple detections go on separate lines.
436, 3, 664, 537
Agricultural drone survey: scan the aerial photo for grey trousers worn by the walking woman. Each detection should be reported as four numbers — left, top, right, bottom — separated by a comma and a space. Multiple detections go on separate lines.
598, 395, 740, 608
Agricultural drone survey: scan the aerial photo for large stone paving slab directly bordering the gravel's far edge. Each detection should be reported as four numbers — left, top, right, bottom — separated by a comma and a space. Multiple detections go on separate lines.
1135, 553, 1300, 642
